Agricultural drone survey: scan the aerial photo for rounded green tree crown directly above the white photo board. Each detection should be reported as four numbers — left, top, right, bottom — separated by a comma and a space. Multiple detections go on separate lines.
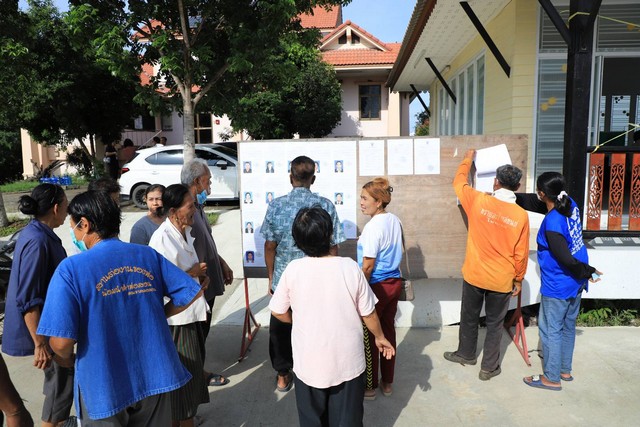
224, 31, 342, 139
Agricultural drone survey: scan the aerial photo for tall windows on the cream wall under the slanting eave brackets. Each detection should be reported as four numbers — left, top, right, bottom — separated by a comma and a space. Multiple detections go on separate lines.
438, 56, 484, 135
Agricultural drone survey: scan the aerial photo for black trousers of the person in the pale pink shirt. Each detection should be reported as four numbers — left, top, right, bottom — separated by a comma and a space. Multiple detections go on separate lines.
294, 373, 364, 427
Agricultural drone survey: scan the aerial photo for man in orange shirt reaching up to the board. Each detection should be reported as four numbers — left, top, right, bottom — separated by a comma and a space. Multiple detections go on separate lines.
444, 150, 529, 381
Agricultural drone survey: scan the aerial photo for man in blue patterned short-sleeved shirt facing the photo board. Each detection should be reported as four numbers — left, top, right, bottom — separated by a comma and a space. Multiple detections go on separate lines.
261, 156, 346, 392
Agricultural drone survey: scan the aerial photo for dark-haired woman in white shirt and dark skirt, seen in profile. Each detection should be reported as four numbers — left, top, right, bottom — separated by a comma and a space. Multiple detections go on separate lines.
149, 184, 209, 427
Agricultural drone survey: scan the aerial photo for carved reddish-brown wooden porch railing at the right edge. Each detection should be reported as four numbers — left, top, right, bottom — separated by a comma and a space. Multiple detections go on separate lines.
583, 146, 640, 237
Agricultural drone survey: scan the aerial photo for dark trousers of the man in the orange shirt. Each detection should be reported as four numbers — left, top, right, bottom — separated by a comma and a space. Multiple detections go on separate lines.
456, 281, 511, 371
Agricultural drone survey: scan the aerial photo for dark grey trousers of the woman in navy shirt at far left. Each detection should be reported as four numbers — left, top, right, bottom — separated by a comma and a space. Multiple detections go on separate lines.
42, 360, 74, 424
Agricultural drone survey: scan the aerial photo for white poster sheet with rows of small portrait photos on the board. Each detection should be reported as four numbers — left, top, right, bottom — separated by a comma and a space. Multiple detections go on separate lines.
238, 141, 359, 267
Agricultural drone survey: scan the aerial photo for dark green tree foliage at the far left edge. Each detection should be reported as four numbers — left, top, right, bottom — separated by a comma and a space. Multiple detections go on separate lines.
0, 0, 139, 162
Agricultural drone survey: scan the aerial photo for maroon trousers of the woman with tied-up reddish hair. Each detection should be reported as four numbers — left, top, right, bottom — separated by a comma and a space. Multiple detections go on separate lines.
363, 278, 402, 389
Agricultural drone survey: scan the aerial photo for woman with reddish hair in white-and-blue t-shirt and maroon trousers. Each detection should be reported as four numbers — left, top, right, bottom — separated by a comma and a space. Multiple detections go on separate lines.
358, 178, 402, 400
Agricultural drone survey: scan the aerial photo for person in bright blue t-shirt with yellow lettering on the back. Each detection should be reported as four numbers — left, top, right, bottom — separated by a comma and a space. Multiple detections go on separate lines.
38, 192, 202, 427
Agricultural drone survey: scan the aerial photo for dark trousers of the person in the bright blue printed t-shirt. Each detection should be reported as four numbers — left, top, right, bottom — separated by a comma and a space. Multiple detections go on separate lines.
79, 393, 171, 427
